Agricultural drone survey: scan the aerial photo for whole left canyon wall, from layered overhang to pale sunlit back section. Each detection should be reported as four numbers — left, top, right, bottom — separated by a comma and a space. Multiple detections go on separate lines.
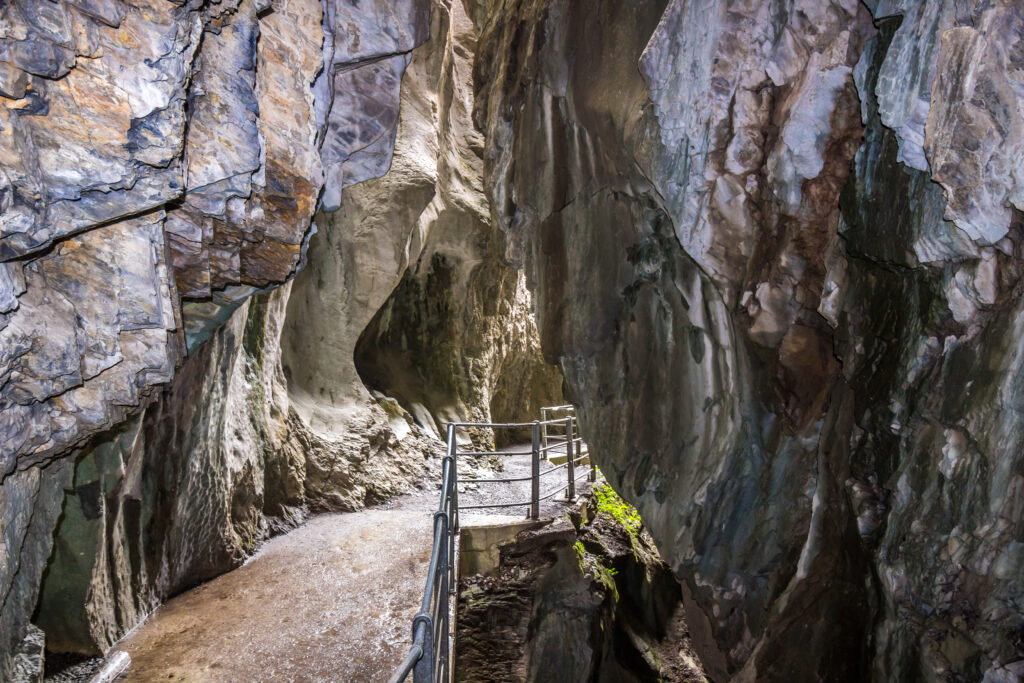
0, 0, 561, 680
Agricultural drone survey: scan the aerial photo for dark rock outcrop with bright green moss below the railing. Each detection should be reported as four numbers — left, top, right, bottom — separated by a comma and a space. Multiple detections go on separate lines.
455, 489, 706, 682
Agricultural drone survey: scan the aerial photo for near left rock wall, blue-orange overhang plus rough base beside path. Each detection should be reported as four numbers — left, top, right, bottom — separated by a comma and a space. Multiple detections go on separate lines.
0, 0, 430, 680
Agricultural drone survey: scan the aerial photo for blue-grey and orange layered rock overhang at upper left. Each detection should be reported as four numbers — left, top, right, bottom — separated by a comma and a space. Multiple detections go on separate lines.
0, 0, 429, 476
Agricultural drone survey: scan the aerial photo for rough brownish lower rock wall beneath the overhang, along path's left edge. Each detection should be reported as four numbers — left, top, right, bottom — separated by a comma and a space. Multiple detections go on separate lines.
33, 284, 433, 654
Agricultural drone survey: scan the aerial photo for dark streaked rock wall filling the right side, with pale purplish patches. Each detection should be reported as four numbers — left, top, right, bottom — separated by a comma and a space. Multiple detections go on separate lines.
471, 0, 1024, 681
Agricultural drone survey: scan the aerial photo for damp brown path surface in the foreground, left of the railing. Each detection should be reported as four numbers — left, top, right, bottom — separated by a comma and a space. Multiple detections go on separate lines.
110, 506, 432, 682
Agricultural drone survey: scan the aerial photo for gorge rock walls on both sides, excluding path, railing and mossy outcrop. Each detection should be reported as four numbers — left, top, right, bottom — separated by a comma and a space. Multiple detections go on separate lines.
0, 0, 1024, 683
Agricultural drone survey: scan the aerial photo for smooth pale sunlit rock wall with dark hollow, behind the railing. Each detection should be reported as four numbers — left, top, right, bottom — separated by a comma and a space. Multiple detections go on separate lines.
282, 1, 561, 448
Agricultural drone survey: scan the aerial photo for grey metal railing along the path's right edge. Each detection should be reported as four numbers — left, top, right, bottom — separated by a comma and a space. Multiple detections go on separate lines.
389, 405, 597, 683
